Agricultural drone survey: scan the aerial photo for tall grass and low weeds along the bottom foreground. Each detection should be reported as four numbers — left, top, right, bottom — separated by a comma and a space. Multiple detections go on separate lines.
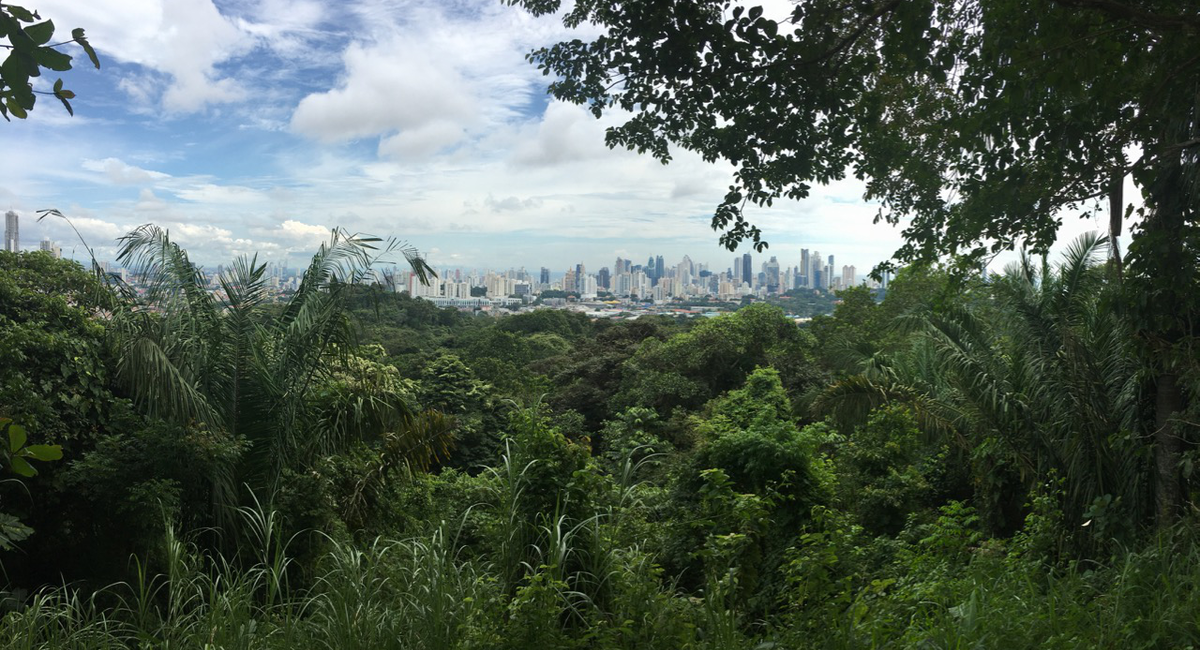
11, 455, 1200, 650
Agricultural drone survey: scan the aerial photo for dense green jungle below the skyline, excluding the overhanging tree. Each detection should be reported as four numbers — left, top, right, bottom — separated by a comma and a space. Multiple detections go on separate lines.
0, 227, 1200, 649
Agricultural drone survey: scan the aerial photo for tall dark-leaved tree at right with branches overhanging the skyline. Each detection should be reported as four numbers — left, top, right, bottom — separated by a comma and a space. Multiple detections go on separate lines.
520, 0, 1200, 523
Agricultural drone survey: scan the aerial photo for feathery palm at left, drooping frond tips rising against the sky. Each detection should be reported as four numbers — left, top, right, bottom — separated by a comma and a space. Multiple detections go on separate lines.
113, 225, 450, 516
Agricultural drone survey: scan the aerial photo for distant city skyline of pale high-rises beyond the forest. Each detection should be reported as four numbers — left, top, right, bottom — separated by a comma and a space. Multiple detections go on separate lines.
4, 211, 887, 309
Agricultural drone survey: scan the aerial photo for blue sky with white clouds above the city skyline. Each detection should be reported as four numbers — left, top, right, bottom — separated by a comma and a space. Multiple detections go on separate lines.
0, 0, 1130, 275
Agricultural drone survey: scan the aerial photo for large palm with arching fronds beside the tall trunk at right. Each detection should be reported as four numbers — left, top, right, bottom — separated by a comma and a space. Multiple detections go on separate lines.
814, 234, 1153, 551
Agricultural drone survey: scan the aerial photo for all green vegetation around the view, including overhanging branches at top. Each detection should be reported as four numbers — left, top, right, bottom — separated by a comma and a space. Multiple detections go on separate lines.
7, 0, 1200, 650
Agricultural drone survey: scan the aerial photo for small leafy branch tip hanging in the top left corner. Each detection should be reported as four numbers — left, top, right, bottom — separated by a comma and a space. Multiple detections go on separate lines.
0, 5, 100, 121
